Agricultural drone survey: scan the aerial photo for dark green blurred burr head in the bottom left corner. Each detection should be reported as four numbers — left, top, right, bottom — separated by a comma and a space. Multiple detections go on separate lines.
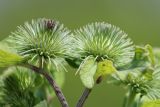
0, 68, 41, 107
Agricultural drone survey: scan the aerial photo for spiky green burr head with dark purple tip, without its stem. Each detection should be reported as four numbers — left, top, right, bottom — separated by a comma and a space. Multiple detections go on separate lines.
8, 18, 70, 69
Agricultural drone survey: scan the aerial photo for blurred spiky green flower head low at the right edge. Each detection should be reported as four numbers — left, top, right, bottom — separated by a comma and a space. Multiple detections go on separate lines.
110, 67, 160, 100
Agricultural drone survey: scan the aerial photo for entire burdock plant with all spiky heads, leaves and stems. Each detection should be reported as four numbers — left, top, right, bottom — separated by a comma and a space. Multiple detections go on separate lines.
0, 18, 160, 107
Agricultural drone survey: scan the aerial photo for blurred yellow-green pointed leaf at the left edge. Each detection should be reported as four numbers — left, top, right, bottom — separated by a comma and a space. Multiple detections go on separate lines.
0, 50, 26, 68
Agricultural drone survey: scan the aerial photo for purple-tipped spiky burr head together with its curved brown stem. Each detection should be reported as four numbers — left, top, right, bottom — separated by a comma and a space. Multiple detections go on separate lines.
1, 18, 70, 107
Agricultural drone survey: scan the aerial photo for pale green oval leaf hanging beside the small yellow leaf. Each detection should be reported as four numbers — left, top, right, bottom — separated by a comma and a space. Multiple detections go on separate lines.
79, 56, 97, 89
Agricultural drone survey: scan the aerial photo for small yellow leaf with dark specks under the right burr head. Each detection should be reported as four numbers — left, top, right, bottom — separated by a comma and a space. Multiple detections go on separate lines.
95, 59, 116, 80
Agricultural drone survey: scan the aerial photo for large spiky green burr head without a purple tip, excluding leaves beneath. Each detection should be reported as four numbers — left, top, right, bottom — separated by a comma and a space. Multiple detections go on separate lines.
74, 22, 134, 67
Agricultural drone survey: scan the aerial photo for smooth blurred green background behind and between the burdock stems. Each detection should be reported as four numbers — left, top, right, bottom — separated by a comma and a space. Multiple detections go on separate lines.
0, 0, 160, 107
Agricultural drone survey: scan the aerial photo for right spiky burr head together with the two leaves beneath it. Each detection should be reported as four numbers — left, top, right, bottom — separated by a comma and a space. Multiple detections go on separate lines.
73, 23, 135, 88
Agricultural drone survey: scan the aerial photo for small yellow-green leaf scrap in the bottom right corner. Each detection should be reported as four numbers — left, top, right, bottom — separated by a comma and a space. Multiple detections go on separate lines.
141, 100, 160, 107
